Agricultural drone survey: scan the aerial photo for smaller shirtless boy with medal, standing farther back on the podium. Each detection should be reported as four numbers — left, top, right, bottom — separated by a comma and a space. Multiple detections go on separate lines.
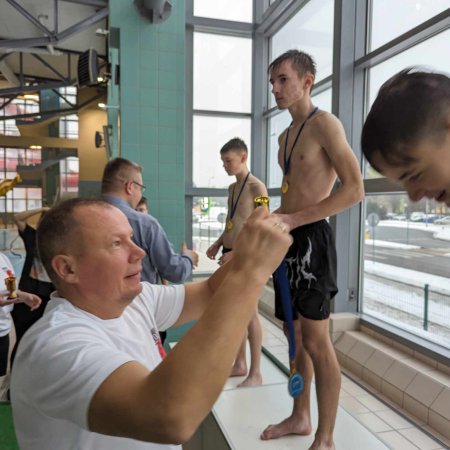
206, 138, 267, 387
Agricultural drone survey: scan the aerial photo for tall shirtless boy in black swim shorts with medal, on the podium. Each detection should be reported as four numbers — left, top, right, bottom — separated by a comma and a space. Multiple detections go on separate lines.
261, 50, 364, 450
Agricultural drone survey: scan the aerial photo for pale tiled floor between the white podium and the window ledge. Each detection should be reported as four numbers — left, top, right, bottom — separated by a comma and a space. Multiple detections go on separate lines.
261, 316, 450, 450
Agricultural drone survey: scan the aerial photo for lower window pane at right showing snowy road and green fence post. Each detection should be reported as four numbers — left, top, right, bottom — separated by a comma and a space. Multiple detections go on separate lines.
362, 194, 450, 345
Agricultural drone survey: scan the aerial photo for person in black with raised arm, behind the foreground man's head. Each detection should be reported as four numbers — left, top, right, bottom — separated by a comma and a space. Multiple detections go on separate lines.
11, 207, 55, 364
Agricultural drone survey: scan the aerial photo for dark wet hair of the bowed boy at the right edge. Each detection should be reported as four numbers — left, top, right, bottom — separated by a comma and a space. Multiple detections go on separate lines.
361, 68, 450, 170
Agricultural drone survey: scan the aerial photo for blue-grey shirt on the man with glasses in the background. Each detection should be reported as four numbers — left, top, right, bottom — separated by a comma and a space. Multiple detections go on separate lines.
103, 195, 193, 284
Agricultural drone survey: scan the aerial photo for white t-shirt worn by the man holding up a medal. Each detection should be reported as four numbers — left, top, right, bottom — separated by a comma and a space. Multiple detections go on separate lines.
11, 282, 184, 450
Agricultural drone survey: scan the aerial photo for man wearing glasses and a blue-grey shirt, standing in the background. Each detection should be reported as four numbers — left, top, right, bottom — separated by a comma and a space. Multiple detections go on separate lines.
102, 158, 198, 284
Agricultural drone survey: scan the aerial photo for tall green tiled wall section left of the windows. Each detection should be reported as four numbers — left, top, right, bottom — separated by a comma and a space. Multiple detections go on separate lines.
109, 0, 185, 246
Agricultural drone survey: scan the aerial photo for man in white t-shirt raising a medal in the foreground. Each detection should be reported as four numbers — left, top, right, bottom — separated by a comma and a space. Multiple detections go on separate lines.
11, 199, 291, 450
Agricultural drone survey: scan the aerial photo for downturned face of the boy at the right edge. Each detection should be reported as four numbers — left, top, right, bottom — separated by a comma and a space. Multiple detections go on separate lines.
374, 129, 450, 206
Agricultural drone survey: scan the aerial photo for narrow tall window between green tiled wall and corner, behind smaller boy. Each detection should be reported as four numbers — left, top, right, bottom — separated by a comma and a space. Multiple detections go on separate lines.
191, 25, 253, 270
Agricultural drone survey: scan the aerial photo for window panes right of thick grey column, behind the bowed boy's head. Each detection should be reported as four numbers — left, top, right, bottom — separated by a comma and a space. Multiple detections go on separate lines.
360, 5, 450, 347
